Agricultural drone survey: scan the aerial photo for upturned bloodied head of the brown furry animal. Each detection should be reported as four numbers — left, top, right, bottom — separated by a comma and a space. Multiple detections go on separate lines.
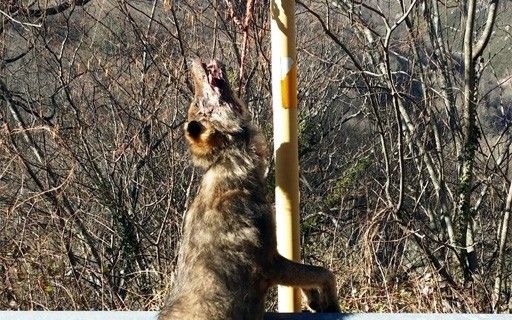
185, 59, 268, 171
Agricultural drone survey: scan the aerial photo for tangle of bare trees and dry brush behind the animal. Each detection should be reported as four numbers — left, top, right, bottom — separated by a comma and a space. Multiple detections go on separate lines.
0, 0, 512, 312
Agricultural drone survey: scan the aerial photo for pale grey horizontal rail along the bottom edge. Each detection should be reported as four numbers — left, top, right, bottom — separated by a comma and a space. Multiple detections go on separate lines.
0, 311, 512, 320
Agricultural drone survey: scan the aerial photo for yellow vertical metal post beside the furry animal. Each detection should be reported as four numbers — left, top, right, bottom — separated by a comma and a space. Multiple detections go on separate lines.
271, 0, 301, 312
